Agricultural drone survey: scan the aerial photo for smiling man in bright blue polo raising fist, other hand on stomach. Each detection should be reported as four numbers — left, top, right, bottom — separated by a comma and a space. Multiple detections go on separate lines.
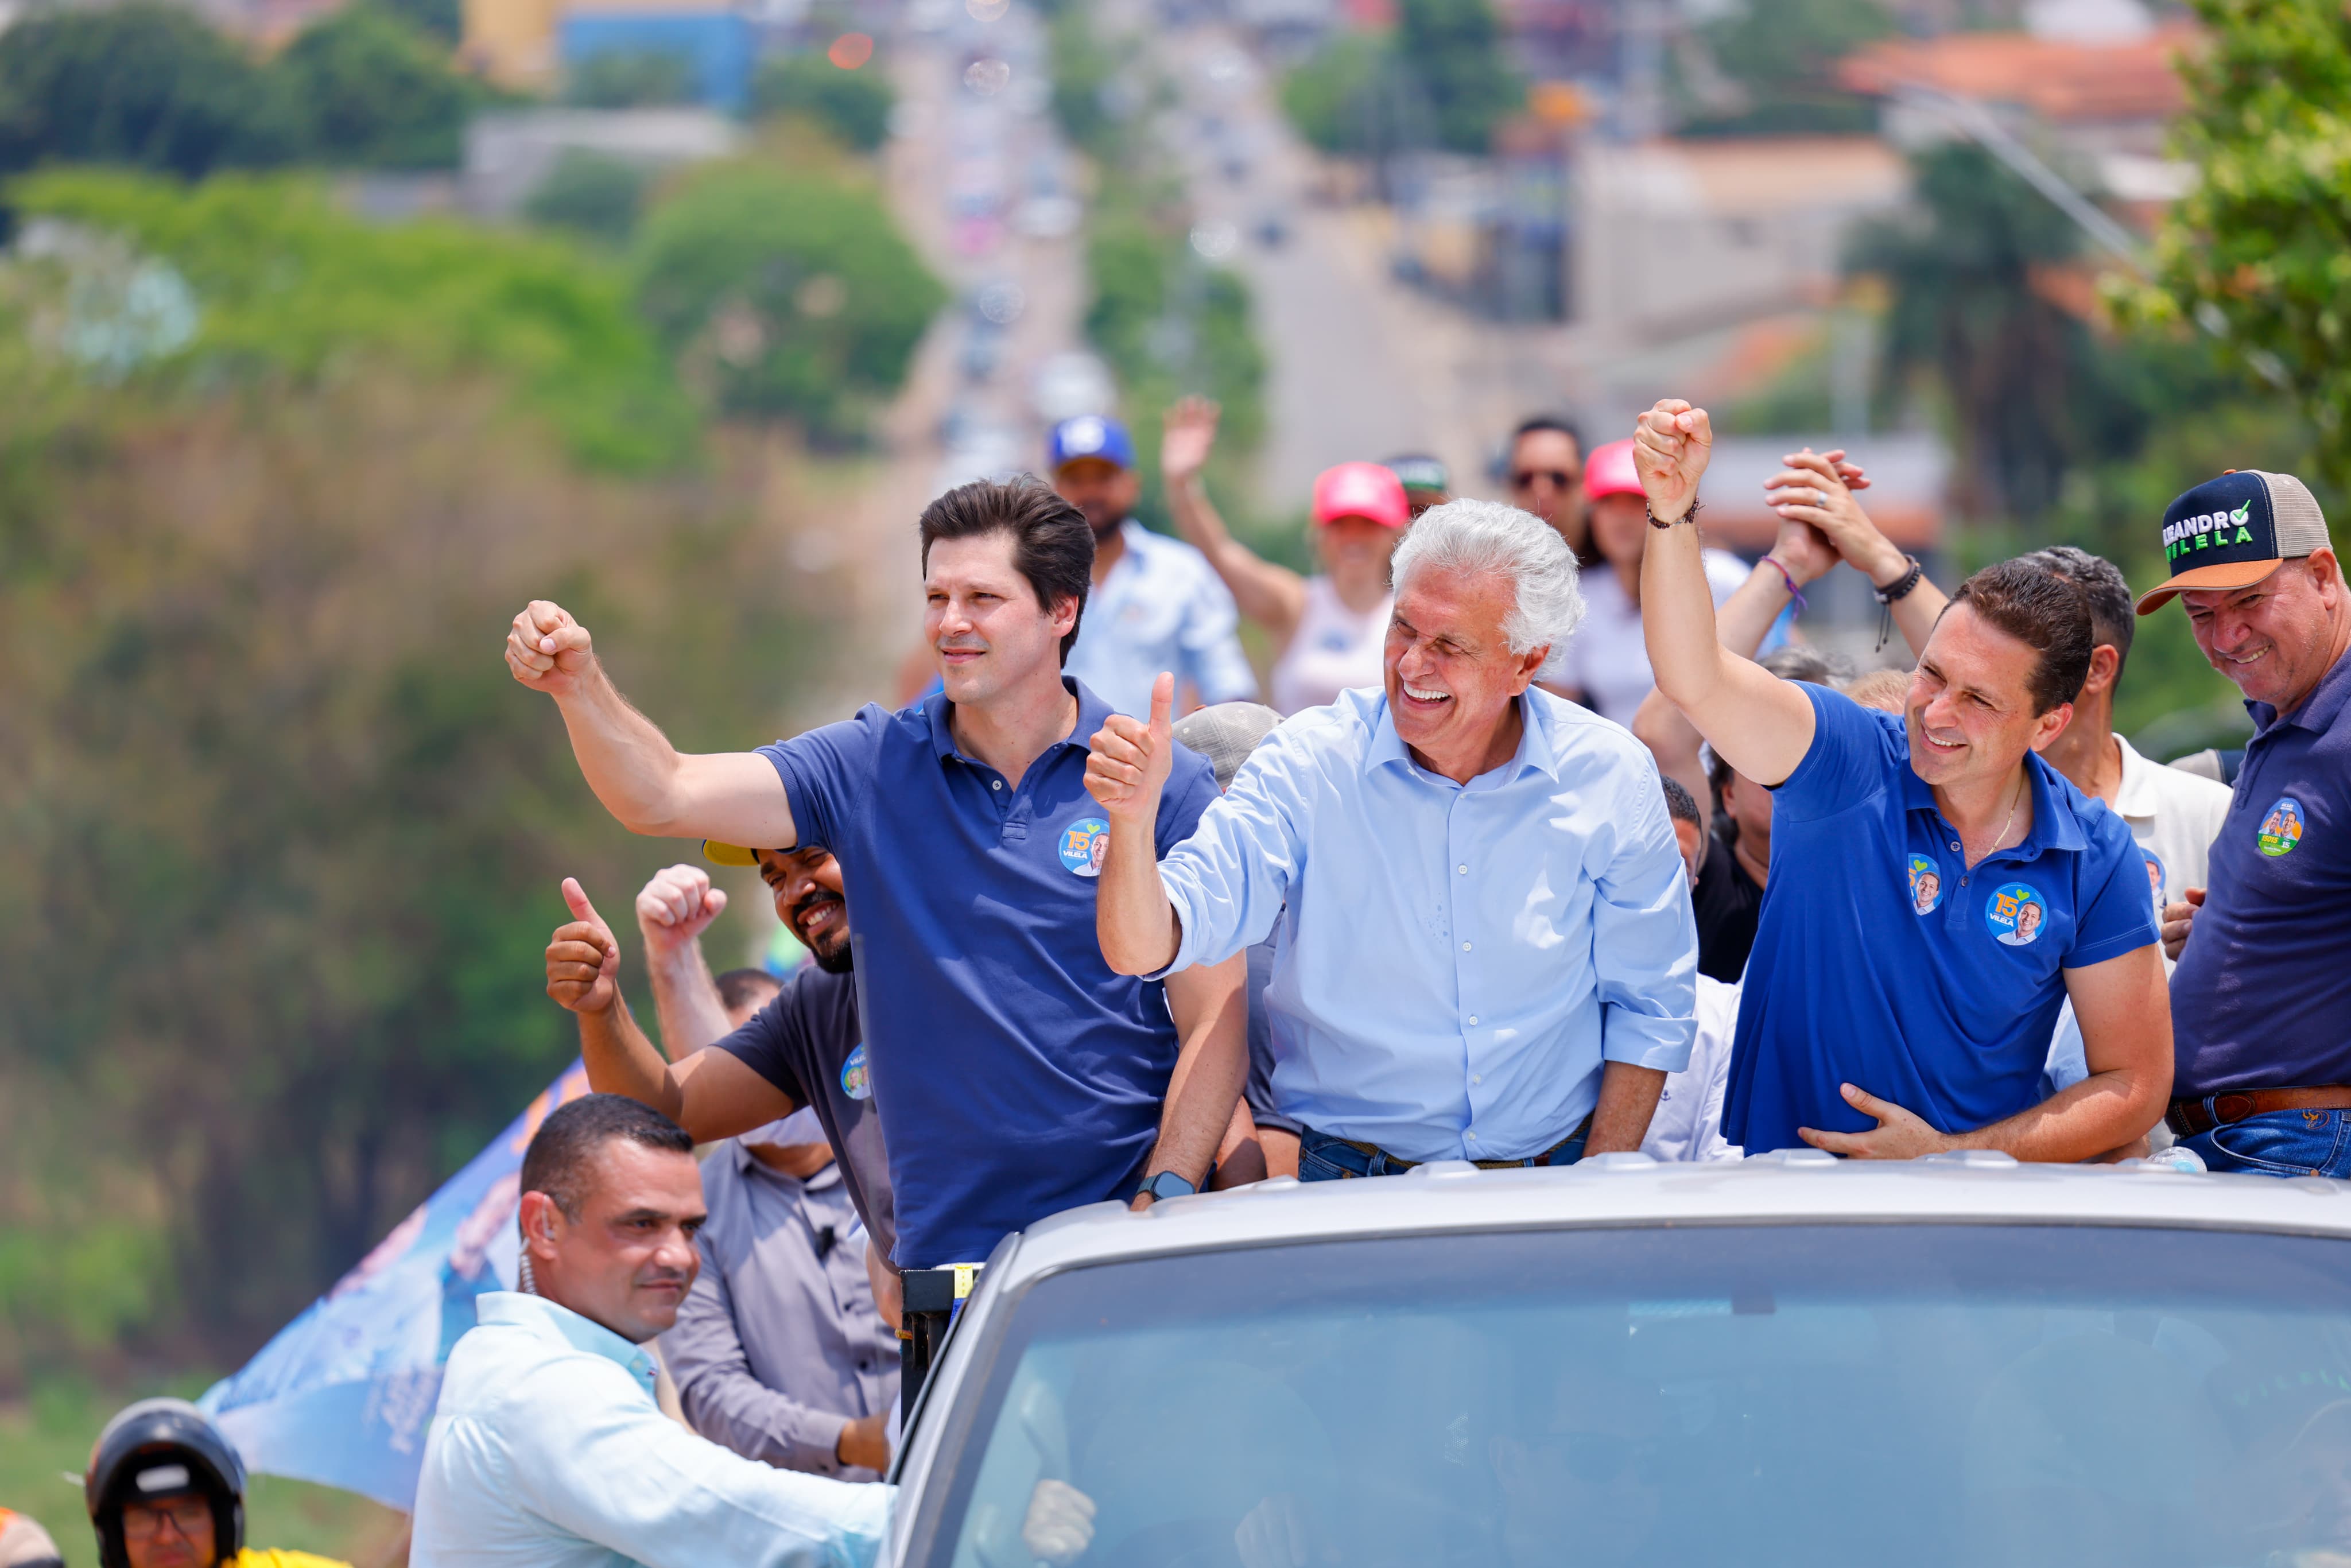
1636, 399, 2172, 1161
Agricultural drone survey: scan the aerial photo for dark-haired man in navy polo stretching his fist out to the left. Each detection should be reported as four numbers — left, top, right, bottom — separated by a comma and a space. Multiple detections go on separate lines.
506, 482, 1248, 1270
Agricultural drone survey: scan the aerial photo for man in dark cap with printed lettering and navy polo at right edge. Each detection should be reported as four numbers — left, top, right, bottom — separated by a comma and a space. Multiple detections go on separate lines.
2139, 470, 2351, 1175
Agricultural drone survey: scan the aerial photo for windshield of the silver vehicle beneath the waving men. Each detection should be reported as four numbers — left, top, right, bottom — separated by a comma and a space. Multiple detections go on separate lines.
914, 1225, 2351, 1568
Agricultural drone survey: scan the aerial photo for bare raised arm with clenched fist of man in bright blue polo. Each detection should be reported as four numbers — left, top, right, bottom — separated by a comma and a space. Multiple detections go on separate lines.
1634, 397, 1813, 785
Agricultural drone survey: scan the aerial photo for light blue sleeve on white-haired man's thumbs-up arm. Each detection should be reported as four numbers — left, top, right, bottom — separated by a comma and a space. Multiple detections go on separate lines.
1147, 731, 1305, 980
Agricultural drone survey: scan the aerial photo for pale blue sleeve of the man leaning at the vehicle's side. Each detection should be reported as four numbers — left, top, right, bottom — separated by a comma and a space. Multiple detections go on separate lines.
501, 1359, 896, 1568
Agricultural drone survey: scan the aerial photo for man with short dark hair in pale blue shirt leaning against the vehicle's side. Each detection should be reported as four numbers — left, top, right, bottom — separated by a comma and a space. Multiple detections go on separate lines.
409, 1096, 1093, 1568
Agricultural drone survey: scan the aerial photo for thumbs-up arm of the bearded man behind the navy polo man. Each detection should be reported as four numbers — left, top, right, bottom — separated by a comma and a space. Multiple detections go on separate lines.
548, 877, 800, 1143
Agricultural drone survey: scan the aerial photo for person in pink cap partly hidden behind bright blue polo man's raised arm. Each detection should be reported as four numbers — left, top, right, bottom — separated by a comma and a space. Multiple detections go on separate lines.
1540, 440, 1758, 727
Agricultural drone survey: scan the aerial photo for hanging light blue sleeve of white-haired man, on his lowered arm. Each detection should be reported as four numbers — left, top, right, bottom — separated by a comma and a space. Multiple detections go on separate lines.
1592, 766, 1697, 1072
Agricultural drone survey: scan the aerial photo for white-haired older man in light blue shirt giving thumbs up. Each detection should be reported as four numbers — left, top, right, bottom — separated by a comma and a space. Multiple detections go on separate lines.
1086, 500, 1697, 1180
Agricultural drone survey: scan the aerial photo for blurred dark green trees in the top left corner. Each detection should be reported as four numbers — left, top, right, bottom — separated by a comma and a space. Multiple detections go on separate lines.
0, 0, 494, 178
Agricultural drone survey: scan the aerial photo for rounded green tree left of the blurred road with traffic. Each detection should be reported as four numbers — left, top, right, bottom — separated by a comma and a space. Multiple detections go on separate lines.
633, 162, 948, 442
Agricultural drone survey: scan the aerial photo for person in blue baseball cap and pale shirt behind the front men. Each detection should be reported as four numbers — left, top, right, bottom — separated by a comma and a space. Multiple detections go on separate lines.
1046, 414, 1258, 715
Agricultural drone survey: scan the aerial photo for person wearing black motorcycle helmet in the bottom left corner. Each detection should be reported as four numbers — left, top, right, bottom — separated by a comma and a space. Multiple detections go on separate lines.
82, 1399, 350, 1568
